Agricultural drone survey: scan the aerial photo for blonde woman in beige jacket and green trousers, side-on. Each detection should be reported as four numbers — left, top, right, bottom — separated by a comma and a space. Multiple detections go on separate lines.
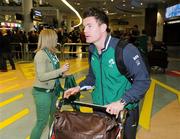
30, 29, 69, 139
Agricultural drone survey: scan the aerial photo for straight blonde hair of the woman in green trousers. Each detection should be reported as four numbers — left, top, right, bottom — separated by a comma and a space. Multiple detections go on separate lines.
36, 29, 58, 53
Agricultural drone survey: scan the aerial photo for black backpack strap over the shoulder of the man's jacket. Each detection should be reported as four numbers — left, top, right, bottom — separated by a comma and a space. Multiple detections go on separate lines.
115, 40, 132, 83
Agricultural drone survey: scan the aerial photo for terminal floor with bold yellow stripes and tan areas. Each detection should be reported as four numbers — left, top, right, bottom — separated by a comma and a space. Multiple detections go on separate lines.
0, 58, 180, 139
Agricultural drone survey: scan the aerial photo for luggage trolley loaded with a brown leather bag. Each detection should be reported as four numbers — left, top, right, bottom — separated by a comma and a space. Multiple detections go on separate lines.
49, 99, 127, 139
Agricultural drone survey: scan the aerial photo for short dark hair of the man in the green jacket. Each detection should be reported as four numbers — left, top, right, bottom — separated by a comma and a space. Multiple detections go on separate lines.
83, 7, 109, 27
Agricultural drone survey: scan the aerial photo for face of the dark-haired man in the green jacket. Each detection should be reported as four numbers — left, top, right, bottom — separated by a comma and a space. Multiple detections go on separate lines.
83, 16, 103, 43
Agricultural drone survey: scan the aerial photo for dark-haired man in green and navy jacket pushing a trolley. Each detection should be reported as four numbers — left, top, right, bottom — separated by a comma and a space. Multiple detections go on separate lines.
64, 8, 150, 139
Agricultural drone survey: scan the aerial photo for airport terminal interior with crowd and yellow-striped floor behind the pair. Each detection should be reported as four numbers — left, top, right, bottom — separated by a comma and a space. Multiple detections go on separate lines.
0, 0, 180, 139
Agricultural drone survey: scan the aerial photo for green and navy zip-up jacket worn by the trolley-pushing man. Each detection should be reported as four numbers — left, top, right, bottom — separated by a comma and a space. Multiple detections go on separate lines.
80, 36, 150, 109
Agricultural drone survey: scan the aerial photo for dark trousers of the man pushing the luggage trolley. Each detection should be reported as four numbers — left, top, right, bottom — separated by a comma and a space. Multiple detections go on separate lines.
123, 107, 139, 139
